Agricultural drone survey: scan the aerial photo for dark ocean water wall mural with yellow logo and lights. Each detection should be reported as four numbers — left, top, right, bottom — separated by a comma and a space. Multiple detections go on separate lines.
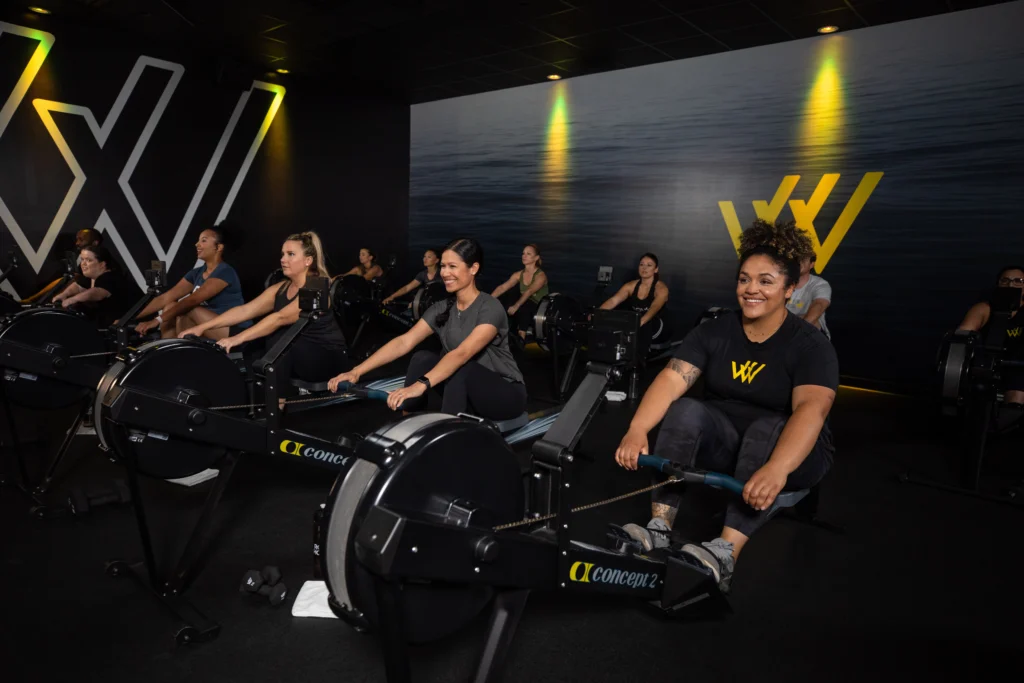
410, 2, 1024, 383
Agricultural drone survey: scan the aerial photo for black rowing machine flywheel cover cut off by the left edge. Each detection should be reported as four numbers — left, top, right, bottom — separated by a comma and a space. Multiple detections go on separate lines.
0, 308, 112, 409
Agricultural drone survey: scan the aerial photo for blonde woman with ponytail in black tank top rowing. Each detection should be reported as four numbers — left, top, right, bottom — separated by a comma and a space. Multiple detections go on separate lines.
179, 232, 351, 382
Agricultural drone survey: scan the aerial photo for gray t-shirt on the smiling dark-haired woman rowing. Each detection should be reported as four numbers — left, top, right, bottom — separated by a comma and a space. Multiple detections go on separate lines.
423, 292, 522, 383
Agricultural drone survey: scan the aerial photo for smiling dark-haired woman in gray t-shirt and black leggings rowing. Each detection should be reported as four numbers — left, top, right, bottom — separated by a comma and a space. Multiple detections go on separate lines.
330, 239, 526, 420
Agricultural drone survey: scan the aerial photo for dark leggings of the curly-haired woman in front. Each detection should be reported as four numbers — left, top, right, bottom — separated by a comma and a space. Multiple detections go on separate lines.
651, 397, 835, 537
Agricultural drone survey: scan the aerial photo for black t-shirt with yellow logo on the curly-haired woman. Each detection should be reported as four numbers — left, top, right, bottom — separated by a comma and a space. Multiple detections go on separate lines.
675, 311, 839, 433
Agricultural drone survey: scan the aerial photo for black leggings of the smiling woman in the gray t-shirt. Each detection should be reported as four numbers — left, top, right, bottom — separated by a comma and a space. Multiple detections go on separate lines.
402, 351, 526, 420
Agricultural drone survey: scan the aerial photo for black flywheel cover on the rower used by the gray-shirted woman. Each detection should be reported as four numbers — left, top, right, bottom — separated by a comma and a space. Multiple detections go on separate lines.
95, 339, 248, 479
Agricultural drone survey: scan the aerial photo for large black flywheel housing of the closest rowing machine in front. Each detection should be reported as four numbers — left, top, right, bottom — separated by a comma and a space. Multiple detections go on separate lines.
319, 414, 524, 643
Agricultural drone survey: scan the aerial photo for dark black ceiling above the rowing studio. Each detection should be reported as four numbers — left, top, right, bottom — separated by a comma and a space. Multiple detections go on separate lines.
12, 0, 1019, 102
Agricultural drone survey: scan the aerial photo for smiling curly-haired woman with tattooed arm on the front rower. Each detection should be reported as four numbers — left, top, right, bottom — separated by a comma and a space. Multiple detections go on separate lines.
615, 220, 839, 591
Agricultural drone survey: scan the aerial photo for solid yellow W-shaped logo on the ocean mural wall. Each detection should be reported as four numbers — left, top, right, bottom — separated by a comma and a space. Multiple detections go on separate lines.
718, 171, 884, 272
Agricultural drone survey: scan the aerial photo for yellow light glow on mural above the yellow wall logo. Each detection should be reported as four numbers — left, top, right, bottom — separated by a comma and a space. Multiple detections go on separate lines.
799, 36, 846, 172
